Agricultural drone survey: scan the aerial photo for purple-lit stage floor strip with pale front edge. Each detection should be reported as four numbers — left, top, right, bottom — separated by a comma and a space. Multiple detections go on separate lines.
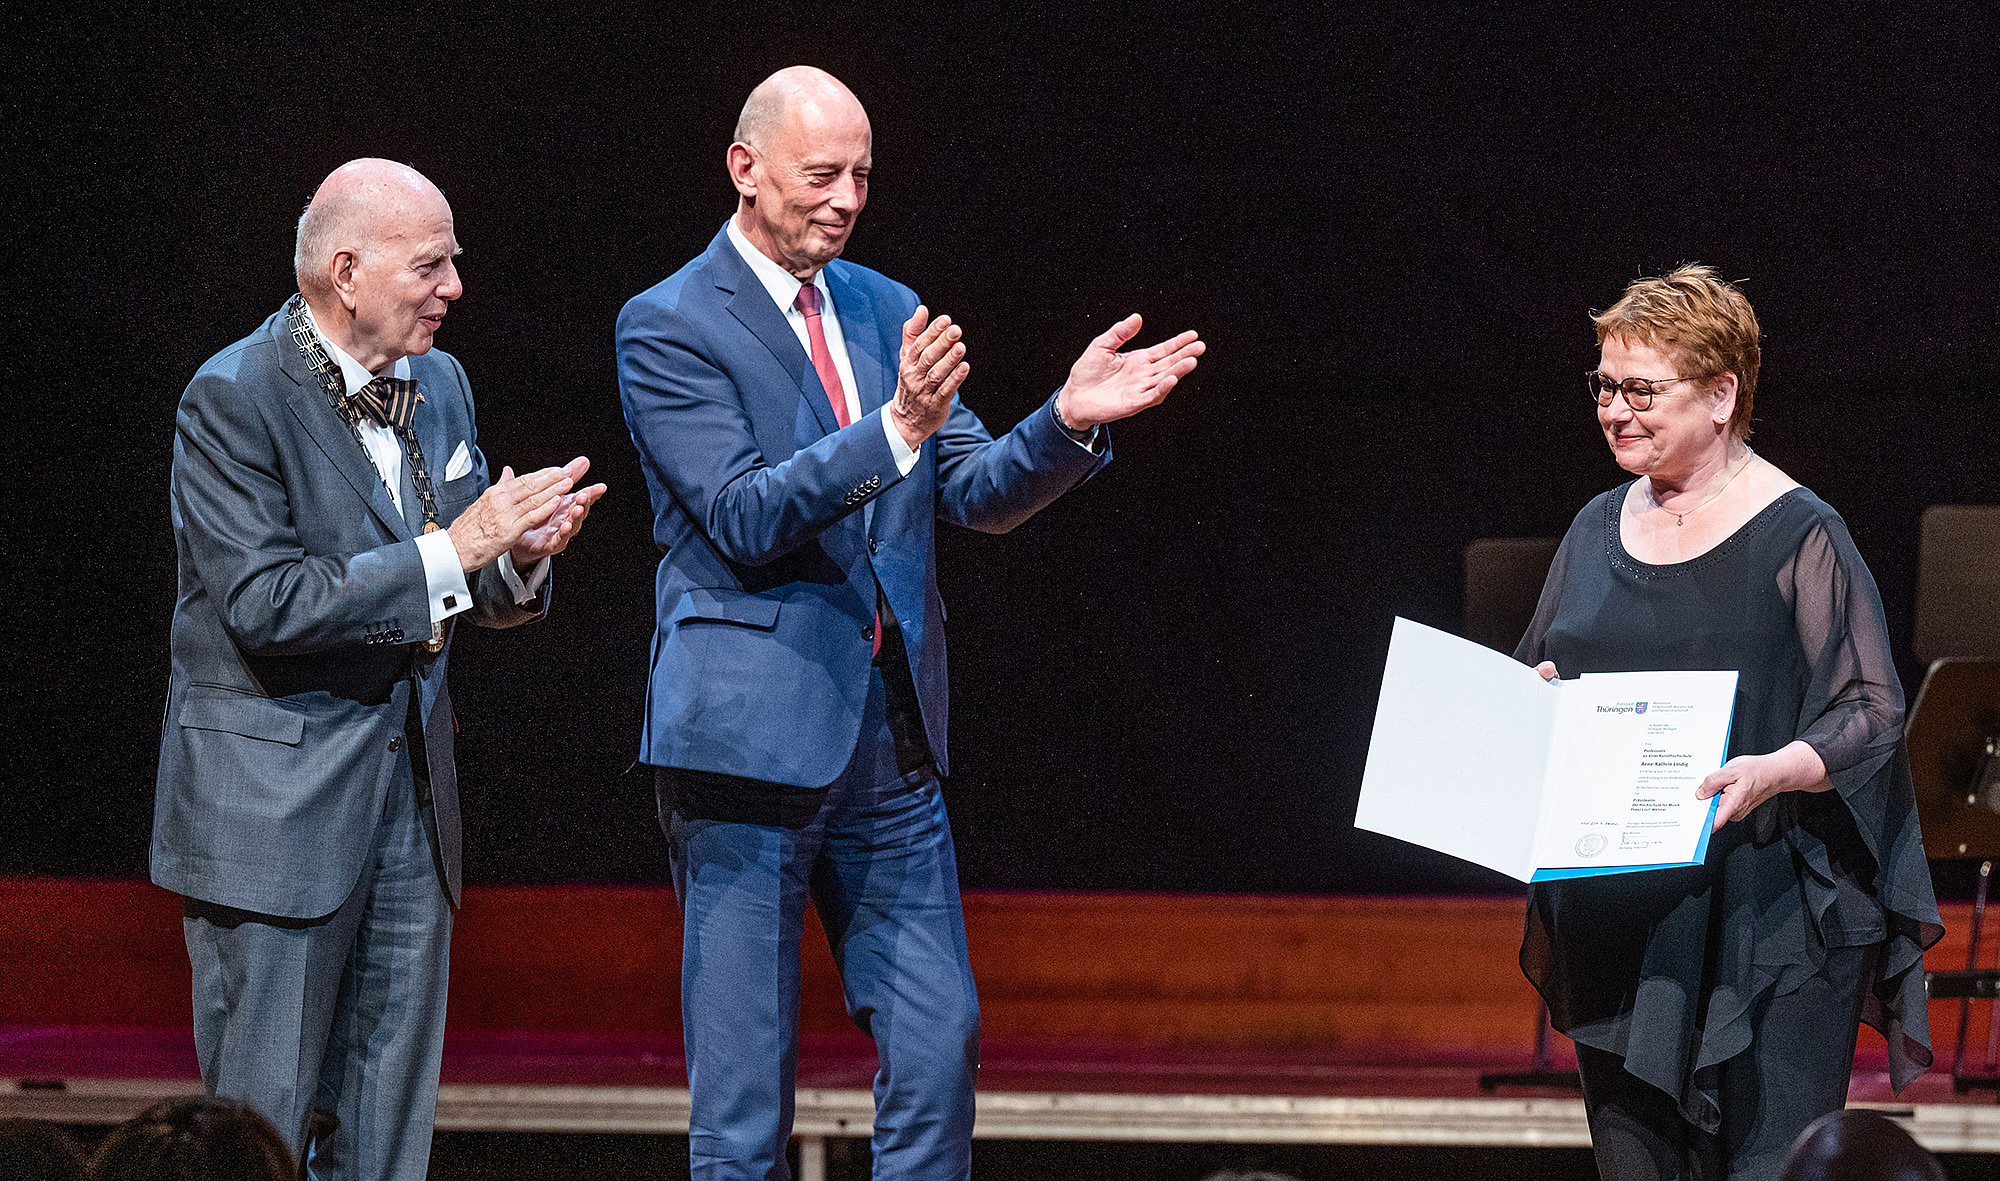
0, 1027, 2000, 1153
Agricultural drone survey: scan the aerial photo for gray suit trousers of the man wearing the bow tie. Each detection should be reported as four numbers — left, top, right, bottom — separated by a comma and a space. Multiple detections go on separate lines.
182, 761, 452, 1181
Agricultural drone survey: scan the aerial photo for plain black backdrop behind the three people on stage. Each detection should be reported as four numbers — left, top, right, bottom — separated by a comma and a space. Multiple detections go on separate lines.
0, 2, 2000, 893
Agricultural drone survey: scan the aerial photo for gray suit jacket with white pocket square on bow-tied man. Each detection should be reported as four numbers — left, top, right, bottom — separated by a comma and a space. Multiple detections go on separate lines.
152, 312, 548, 919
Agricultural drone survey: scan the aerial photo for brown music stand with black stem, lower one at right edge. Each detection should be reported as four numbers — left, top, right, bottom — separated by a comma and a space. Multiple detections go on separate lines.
1904, 657, 2000, 1093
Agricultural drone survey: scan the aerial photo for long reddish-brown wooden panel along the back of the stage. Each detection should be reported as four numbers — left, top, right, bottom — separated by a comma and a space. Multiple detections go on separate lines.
0, 879, 1984, 1059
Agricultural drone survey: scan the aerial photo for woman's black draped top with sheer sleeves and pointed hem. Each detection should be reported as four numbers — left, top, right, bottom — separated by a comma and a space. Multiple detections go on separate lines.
1514, 484, 1944, 1131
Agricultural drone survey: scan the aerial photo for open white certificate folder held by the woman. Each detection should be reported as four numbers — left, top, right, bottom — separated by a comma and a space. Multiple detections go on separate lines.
1354, 619, 1736, 881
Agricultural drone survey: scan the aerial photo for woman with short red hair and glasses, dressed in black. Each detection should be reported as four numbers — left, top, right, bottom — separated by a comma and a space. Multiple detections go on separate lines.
1514, 266, 1942, 1181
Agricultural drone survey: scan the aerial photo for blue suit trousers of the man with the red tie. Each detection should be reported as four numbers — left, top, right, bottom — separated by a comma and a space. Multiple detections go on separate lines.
660, 671, 980, 1181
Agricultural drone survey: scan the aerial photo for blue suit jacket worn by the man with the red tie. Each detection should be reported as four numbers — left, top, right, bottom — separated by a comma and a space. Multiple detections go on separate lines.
618, 230, 1110, 787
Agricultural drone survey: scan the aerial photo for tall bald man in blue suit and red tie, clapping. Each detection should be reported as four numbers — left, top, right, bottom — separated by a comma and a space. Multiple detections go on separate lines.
618, 66, 1204, 1179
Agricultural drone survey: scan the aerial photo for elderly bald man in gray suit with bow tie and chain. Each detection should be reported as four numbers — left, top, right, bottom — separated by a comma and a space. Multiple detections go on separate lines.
152, 160, 604, 1179
